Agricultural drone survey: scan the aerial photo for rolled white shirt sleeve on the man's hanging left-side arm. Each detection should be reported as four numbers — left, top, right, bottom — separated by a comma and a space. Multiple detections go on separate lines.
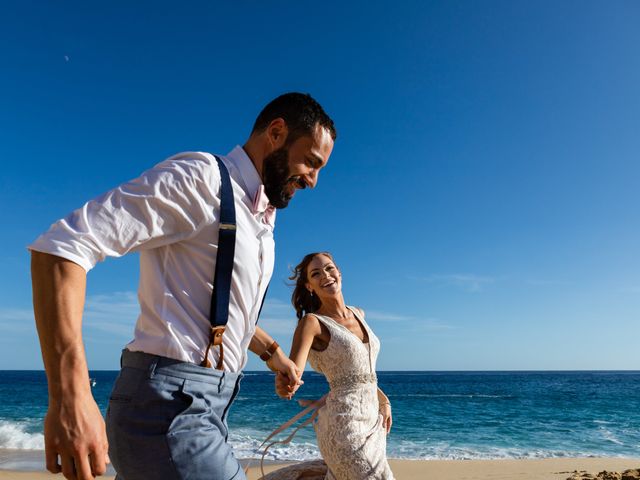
27, 152, 220, 271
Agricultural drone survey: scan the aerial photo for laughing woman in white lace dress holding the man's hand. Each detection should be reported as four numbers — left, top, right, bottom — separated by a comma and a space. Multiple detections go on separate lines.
265, 252, 394, 480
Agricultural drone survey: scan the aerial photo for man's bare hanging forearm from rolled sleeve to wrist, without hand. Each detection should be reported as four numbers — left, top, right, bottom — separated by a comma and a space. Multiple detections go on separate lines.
31, 252, 90, 402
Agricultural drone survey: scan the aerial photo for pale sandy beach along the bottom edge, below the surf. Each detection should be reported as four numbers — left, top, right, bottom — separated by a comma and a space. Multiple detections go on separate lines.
0, 458, 640, 480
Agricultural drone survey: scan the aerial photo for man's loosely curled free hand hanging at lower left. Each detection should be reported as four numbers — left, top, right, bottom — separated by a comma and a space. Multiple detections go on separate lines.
44, 393, 109, 480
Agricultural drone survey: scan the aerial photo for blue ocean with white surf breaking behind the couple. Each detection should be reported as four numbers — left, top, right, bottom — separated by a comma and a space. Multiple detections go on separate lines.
0, 371, 640, 468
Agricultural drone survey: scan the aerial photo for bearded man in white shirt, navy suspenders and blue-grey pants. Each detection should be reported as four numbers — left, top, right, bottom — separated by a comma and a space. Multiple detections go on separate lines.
29, 93, 336, 480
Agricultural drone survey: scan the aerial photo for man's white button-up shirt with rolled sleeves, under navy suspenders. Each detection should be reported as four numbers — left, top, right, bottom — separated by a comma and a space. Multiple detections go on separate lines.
28, 146, 274, 372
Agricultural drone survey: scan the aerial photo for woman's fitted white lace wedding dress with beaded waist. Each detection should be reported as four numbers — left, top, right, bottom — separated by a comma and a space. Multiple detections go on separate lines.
263, 307, 394, 480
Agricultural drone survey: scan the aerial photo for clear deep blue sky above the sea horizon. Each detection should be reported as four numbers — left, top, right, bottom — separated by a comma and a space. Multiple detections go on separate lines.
0, 1, 640, 370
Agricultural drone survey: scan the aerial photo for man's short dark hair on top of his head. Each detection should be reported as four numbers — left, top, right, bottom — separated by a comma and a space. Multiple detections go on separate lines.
251, 92, 337, 145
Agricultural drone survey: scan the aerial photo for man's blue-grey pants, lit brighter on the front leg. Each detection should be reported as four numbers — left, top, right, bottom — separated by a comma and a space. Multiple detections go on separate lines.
107, 350, 246, 480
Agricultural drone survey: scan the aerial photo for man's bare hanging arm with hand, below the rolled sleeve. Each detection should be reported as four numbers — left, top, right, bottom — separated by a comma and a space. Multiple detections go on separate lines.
31, 251, 108, 480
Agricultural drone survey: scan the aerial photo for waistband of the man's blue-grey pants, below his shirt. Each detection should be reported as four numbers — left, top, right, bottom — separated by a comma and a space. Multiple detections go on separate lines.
120, 349, 243, 389
